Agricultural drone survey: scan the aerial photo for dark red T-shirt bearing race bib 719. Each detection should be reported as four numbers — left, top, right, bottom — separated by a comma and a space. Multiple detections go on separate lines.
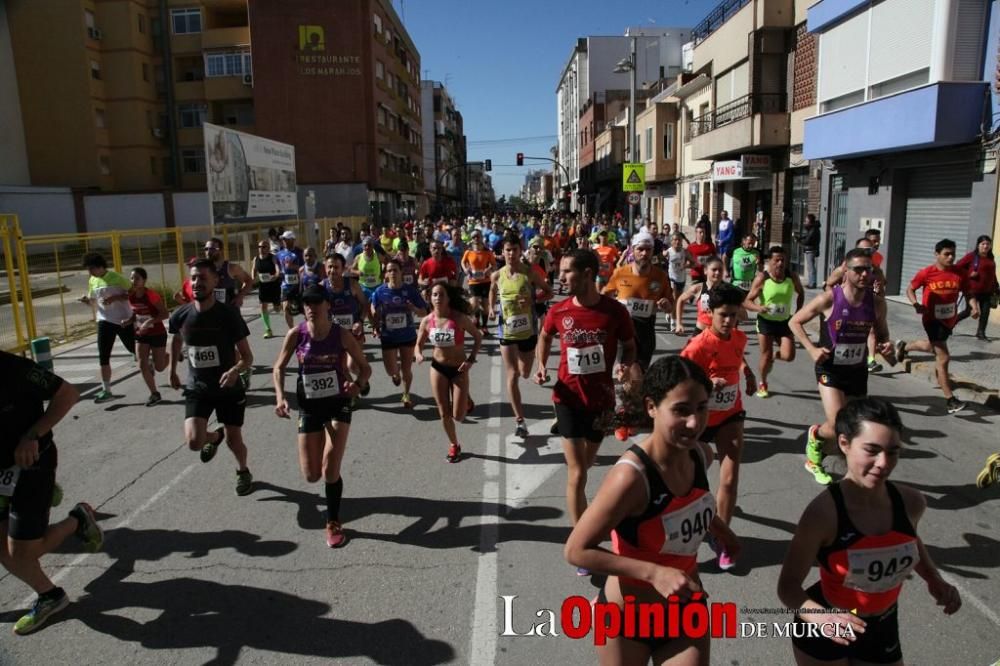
542, 296, 635, 411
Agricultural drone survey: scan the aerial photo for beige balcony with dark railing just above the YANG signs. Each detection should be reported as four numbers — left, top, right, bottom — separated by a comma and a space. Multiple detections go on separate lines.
687, 93, 790, 160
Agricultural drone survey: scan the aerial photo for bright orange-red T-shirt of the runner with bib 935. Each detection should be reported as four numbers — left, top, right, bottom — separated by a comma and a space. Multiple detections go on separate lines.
681, 328, 747, 426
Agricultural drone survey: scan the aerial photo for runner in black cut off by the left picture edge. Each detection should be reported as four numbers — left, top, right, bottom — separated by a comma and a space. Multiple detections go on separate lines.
0, 351, 104, 632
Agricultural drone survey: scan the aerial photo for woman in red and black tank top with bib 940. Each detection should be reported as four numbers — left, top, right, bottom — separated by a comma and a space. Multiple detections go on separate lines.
565, 356, 739, 665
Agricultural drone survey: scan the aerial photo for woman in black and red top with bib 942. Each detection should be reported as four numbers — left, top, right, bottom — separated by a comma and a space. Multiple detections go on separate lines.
778, 397, 962, 666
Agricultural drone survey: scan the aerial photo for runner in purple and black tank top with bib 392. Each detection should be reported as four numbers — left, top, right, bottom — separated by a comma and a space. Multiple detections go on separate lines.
273, 285, 372, 548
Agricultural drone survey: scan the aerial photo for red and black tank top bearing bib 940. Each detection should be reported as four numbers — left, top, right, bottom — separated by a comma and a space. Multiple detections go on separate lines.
611, 444, 715, 587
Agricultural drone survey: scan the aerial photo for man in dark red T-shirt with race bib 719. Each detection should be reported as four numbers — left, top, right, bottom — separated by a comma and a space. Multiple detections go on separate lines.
535, 250, 642, 540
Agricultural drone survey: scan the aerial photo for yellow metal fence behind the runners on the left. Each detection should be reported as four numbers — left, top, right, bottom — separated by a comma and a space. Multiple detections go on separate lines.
0, 215, 366, 353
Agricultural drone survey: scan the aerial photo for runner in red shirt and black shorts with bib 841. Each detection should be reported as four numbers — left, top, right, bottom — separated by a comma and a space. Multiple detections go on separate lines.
896, 238, 980, 414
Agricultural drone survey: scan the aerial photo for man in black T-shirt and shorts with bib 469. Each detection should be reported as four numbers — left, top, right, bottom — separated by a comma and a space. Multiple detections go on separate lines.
169, 259, 253, 495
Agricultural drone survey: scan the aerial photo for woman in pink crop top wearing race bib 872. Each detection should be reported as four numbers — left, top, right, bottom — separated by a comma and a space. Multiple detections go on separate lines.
414, 283, 483, 463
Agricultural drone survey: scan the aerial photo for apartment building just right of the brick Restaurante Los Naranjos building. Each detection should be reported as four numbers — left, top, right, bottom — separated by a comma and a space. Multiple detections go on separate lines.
421, 81, 467, 216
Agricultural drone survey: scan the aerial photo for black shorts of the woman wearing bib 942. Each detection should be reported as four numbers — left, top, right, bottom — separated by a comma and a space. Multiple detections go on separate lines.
792, 582, 903, 664
